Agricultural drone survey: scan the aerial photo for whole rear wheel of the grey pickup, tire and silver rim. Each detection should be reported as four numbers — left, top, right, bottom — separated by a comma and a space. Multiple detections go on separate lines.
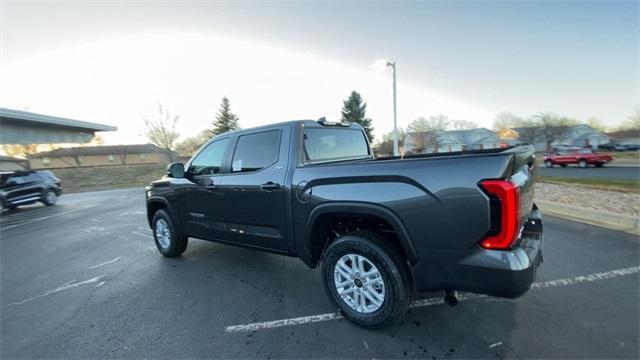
322, 232, 411, 329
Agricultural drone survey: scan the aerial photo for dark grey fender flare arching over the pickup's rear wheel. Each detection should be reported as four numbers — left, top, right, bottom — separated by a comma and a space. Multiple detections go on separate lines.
305, 202, 418, 265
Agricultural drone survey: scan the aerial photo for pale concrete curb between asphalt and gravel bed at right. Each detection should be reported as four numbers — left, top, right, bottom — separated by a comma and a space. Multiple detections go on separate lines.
536, 200, 640, 235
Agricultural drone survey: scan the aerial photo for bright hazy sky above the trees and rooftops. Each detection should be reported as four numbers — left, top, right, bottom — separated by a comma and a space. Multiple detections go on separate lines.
0, 0, 640, 143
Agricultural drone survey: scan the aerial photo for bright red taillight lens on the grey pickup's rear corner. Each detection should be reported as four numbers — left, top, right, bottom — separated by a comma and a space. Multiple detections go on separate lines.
480, 180, 520, 250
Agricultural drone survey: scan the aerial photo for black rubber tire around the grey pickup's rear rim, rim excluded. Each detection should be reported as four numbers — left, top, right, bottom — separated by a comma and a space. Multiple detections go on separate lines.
322, 232, 412, 329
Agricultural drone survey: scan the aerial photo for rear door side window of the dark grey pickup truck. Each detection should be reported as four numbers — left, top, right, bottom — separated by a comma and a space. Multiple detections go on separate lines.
231, 130, 280, 173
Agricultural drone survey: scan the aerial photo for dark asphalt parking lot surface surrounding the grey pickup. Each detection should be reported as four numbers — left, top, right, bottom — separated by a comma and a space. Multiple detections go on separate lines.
0, 189, 640, 358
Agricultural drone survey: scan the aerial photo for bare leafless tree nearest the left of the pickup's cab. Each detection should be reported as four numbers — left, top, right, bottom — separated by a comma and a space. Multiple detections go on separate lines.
144, 103, 180, 161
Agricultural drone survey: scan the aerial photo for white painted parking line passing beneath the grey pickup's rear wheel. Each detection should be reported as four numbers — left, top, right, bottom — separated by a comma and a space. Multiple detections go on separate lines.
224, 266, 640, 334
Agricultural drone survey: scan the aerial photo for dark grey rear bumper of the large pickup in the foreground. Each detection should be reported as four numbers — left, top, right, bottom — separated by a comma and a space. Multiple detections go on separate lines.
412, 205, 543, 298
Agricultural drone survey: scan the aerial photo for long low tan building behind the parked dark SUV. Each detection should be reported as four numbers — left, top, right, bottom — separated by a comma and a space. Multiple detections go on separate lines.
29, 144, 175, 169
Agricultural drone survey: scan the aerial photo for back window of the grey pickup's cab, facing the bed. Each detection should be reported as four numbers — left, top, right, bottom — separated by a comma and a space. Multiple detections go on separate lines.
304, 128, 370, 162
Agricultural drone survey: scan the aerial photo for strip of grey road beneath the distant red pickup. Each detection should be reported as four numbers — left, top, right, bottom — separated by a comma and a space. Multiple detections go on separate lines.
538, 165, 640, 181
